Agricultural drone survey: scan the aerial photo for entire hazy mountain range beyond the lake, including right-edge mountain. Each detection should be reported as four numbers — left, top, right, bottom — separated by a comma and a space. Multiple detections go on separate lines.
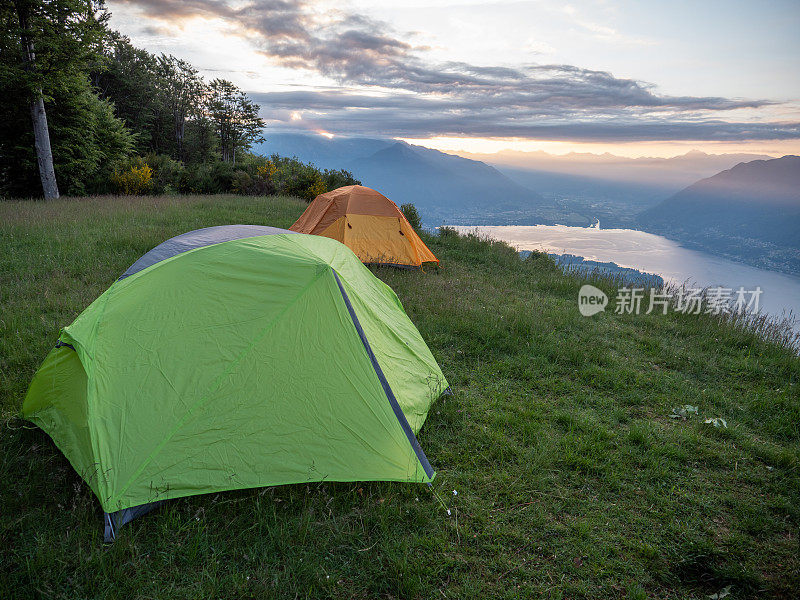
254, 133, 800, 274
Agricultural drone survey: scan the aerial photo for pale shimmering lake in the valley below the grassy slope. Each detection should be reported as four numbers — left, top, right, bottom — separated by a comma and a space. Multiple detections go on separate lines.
455, 225, 800, 329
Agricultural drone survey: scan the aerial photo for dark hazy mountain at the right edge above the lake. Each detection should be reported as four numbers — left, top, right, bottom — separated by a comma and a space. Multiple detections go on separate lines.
638, 156, 800, 273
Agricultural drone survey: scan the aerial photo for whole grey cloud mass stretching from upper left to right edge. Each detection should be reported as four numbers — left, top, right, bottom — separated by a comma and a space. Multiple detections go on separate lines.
118, 0, 800, 140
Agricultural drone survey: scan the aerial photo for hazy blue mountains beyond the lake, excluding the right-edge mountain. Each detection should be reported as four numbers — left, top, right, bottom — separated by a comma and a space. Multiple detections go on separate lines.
254, 133, 776, 227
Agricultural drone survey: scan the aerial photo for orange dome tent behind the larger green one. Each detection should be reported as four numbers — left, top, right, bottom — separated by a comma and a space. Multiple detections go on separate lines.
289, 185, 439, 267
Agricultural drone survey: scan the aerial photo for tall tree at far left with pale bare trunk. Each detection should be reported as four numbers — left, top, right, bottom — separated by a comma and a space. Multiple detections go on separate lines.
0, 0, 108, 198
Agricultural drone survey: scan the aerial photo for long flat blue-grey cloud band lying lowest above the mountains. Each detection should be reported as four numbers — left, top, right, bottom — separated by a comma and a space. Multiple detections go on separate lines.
255, 90, 800, 142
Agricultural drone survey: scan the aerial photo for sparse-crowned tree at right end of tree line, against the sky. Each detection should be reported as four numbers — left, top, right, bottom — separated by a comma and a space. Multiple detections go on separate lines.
206, 79, 264, 164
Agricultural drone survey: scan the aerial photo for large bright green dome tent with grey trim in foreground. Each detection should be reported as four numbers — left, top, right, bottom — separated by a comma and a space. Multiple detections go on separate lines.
22, 225, 447, 539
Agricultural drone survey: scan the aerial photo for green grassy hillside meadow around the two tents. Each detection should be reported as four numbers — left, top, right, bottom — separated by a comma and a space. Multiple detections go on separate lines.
0, 196, 800, 599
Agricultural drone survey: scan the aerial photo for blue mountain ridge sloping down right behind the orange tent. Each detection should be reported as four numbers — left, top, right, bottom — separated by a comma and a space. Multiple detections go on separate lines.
254, 133, 547, 225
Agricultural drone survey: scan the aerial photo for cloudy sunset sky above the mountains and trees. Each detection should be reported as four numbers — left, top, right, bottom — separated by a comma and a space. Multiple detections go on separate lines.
108, 0, 800, 157
